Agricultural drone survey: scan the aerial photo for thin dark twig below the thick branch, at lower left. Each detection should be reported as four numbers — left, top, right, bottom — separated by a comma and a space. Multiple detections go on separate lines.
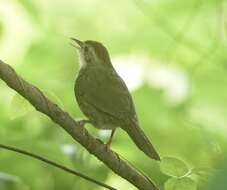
0, 144, 116, 190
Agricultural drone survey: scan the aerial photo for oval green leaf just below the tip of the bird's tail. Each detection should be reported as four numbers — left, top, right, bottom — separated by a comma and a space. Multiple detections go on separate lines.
160, 157, 189, 177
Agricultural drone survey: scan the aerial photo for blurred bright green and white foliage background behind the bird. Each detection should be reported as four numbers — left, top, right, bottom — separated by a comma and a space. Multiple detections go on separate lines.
0, 0, 227, 190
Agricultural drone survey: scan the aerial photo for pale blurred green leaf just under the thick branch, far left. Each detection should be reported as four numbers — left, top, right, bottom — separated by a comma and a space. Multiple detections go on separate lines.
10, 93, 34, 119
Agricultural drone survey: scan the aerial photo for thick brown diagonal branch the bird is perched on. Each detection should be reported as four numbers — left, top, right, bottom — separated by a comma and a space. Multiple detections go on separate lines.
0, 60, 158, 190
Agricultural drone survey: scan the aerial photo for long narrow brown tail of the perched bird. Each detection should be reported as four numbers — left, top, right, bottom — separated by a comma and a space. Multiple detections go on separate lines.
124, 122, 160, 160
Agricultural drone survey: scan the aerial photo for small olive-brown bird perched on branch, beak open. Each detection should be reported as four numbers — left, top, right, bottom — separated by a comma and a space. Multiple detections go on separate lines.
71, 38, 160, 161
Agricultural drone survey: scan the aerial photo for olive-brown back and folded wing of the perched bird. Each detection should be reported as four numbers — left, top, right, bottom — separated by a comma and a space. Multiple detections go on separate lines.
76, 68, 135, 119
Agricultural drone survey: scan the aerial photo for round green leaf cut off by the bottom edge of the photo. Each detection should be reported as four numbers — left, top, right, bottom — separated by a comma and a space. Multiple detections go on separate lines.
164, 177, 197, 190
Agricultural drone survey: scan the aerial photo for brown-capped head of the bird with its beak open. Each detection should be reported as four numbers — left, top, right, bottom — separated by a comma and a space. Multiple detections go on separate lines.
71, 38, 112, 67
